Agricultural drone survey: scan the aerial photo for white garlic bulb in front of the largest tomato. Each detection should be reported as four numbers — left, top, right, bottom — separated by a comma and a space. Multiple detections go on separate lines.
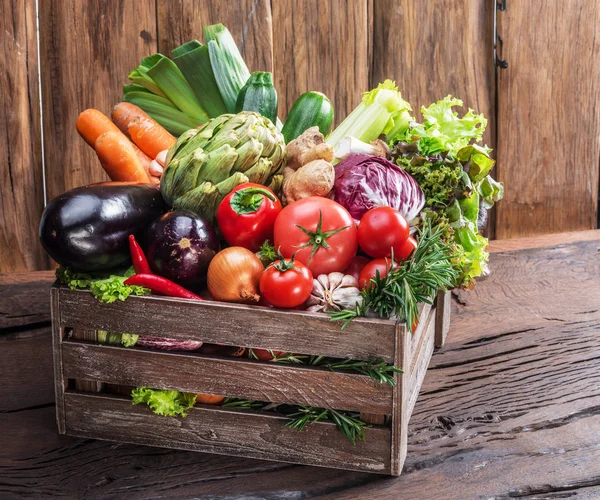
306, 273, 363, 312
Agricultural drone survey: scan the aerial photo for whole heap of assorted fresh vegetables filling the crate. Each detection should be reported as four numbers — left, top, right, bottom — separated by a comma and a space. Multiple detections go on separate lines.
40, 24, 504, 443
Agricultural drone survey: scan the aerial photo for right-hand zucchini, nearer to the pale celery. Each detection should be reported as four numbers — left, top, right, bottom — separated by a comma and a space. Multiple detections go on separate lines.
281, 92, 333, 144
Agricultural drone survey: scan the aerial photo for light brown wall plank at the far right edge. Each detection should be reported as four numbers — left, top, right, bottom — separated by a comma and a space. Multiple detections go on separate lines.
496, 0, 600, 239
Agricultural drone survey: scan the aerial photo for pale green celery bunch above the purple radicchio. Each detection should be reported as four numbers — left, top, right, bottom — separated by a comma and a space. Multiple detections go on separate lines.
327, 80, 412, 147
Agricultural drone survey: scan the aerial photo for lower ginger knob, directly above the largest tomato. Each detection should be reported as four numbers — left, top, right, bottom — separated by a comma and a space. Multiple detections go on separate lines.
283, 159, 335, 203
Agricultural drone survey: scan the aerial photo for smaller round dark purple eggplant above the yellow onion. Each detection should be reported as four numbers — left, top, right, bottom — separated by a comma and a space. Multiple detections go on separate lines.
146, 210, 219, 288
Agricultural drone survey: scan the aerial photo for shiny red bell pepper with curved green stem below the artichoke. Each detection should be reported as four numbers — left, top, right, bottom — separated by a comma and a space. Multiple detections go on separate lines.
217, 182, 281, 252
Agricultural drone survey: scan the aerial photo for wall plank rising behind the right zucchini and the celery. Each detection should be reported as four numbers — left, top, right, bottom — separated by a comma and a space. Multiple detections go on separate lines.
272, 0, 372, 124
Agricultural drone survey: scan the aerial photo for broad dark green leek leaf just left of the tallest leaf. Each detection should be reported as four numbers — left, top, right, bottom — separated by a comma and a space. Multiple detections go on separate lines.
172, 40, 227, 118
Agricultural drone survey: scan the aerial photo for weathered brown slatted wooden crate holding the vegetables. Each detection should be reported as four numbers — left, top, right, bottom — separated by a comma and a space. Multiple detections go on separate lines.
51, 286, 449, 475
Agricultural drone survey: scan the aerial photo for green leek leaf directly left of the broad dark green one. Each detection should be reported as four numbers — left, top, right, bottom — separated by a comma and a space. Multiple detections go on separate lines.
148, 55, 208, 123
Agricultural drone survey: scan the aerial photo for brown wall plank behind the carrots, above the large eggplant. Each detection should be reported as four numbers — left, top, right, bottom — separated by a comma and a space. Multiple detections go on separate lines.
40, 0, 156, 199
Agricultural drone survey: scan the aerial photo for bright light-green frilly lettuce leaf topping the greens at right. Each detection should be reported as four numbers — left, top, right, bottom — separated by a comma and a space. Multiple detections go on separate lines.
411, 95, 487, 155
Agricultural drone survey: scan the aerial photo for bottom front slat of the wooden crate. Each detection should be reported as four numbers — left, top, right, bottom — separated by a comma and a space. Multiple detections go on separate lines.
65, 393, 390, 474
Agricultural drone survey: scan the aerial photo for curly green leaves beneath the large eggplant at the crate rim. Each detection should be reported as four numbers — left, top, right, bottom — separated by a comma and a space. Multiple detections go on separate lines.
56, 267, 150, 304
